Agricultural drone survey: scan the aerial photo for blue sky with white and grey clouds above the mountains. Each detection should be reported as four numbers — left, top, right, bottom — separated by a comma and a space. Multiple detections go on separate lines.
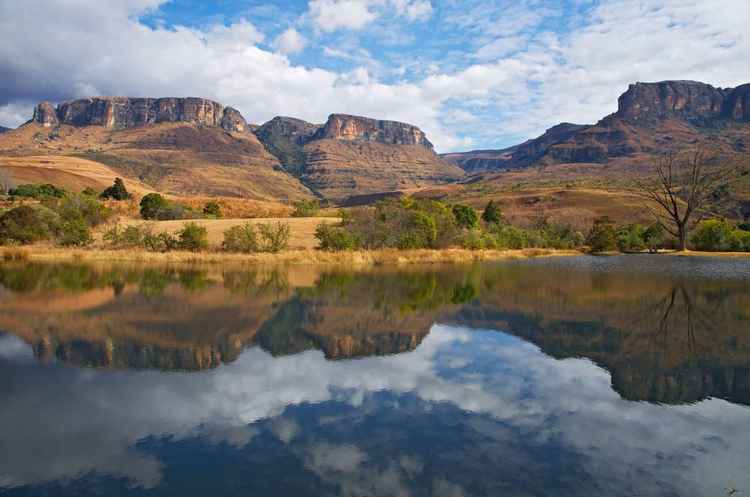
0, 0, 750, 151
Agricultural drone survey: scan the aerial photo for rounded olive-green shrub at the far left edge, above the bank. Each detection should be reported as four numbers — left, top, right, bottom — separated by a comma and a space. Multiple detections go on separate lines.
0, 205, 61, 245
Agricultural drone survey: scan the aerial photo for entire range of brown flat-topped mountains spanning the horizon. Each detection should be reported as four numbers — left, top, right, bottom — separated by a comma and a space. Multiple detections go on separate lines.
0, 81, 750, 214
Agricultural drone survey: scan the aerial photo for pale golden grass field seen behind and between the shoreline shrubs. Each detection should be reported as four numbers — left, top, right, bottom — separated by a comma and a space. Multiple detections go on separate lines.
114, 217, 339, 250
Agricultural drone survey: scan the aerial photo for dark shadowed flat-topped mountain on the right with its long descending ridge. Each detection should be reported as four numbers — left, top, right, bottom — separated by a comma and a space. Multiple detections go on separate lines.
444, 81, 750, 172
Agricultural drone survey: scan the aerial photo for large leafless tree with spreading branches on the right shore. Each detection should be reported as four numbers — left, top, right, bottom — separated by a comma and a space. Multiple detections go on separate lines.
636, 150, 738, 250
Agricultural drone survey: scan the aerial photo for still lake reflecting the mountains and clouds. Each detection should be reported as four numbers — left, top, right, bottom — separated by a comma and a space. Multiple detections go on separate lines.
0, 256, 750, 497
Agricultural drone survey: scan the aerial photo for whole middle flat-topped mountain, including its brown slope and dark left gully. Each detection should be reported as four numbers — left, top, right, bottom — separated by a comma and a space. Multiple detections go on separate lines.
255, 114, 463, 200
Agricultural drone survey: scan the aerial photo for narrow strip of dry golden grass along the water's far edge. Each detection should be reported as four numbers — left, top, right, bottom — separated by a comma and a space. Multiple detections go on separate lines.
2, 245, 581, 267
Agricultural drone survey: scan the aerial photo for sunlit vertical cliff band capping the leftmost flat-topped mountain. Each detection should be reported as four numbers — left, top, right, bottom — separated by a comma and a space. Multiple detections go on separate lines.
33, 97, 248, 132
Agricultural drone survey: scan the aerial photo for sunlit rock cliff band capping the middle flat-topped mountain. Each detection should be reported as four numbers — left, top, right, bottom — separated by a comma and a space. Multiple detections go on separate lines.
314, 114, 432, 149
